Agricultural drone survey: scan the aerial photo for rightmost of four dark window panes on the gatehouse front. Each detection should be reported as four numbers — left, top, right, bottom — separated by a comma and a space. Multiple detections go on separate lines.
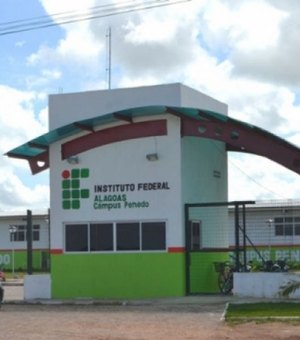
142, 222, 166, 250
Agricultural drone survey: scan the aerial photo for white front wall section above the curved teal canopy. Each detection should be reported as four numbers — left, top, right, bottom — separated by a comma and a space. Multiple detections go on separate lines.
49, 84, 182, 130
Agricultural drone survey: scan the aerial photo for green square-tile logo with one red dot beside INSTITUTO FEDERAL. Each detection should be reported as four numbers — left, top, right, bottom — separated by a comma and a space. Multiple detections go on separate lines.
61, 168, 90, 210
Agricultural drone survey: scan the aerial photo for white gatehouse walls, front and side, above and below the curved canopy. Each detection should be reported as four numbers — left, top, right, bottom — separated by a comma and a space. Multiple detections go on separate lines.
49, 84, 227, 249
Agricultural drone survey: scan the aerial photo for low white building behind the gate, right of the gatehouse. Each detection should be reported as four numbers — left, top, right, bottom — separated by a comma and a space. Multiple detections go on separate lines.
229, 200, 300, 269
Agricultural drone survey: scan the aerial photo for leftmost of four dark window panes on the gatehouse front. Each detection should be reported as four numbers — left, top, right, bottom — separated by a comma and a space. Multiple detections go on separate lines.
66, 224, 88, 251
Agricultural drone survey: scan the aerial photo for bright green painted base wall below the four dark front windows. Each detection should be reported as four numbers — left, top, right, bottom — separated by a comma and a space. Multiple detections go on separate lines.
51, 253, 185, 299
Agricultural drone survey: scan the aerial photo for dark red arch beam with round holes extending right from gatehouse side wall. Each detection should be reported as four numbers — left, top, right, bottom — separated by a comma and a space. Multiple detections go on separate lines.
181, 111, 300, 174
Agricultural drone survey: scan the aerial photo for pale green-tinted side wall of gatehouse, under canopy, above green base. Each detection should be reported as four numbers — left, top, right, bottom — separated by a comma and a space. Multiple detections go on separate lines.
182, 137, 228, 248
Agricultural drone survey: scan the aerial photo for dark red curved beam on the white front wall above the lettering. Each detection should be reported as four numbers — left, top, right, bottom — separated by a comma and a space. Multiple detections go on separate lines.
61, 119, 167, 159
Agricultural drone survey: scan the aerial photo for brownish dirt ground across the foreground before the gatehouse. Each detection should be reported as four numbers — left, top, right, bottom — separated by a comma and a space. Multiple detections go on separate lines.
0, 287, 300, 340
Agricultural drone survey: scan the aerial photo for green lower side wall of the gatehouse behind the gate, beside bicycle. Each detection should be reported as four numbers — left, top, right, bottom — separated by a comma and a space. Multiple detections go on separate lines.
190, 252, 228, 294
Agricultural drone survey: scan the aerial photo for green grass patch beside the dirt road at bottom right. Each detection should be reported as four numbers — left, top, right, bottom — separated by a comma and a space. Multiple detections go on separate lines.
225, 302, 300, 323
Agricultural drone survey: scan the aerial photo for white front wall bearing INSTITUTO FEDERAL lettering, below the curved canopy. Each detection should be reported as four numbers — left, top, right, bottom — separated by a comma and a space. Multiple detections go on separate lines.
50, 116, 183, 249
